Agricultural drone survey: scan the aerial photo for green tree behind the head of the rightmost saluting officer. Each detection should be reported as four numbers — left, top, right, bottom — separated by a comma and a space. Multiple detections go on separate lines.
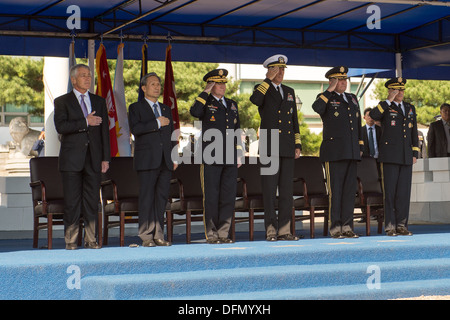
374, 79, 450, 126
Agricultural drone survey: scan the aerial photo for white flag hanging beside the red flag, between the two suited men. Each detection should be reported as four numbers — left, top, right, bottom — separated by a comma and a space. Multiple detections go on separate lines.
113, 43, 131, 156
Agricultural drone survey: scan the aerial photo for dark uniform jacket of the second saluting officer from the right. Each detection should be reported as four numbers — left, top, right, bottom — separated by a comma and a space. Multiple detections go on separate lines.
312, 91, 364, 162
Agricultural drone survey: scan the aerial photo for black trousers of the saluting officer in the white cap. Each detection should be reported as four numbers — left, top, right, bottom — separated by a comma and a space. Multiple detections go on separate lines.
261, 157, 295, 237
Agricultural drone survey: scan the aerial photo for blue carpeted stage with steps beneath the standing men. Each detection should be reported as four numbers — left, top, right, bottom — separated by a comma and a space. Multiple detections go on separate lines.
0, 224, 450, 300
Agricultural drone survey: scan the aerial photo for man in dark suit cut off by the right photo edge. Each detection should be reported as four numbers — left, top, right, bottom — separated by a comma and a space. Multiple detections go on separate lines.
427, 103, 450, 158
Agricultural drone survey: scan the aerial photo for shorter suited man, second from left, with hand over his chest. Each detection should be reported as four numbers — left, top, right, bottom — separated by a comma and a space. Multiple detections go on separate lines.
128, 72, 177, 247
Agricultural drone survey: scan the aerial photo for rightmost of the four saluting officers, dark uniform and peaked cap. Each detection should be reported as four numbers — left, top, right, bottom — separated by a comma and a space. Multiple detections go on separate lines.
370, 77, 419, 236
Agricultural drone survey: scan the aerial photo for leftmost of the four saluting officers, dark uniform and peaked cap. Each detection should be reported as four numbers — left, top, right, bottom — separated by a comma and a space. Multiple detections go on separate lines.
190, 69, 242, 244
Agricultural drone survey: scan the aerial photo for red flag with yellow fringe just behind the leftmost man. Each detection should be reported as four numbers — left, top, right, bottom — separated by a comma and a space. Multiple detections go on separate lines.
95, 44, 119, 157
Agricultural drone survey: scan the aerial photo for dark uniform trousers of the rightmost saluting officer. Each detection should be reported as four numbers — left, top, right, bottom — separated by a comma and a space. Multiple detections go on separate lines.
381, 163, 412, 231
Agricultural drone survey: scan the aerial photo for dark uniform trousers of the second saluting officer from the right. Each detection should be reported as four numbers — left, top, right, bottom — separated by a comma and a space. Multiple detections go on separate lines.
325, 160, 357, 235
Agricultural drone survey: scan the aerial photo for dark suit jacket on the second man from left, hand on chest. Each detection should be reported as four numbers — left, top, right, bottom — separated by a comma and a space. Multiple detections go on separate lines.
128, 99, 177, 171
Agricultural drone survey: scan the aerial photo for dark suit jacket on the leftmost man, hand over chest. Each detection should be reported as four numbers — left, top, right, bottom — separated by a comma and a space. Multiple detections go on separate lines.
54, 91, 111, 172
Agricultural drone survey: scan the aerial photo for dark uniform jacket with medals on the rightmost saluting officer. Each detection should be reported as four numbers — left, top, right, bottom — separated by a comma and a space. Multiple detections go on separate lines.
370, 101, 419, 165
